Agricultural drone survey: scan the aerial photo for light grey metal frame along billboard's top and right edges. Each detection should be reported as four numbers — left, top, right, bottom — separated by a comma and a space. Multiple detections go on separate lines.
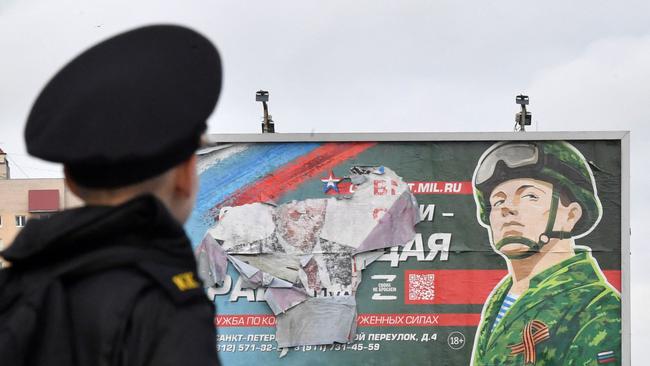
208, 131, 632, 365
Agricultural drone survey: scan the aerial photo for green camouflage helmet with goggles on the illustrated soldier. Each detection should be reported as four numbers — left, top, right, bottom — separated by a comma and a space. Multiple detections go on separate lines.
472, 141, 602, 237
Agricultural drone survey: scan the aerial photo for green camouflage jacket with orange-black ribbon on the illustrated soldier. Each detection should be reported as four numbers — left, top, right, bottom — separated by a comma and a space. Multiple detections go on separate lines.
472, 251, 621, 366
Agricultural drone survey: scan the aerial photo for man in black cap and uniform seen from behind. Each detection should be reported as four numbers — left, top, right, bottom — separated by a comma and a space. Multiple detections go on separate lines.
0, 25, 221, 366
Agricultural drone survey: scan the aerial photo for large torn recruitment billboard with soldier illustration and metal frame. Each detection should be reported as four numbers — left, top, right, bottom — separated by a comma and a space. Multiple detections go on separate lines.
186, 132, 629, 365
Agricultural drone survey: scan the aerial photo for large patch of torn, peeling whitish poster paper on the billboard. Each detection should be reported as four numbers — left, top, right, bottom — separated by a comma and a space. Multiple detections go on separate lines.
199, 167, 420, 347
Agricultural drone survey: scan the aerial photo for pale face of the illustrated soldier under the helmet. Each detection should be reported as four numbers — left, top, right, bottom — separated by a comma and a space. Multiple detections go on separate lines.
490, 178, 553, 254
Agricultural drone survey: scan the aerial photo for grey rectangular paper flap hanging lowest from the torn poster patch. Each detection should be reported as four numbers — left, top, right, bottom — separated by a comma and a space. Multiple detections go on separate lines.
276, 296, 356, 348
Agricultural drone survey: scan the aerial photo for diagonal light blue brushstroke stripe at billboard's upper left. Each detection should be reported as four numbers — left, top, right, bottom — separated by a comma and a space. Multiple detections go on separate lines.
185, 143, 320, 247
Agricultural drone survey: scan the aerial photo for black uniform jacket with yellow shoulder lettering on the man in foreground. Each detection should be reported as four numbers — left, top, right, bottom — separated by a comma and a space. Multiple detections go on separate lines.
0, 195, 219, 366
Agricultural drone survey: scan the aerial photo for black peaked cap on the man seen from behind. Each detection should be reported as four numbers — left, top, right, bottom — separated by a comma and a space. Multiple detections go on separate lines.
25, 25, 221, 188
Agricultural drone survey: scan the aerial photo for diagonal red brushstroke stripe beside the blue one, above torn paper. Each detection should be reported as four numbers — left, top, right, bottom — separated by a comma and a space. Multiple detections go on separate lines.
219, 142, 376, 206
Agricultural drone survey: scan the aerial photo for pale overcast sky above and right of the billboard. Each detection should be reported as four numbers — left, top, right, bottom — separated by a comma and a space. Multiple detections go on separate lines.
0, 0, 650, 364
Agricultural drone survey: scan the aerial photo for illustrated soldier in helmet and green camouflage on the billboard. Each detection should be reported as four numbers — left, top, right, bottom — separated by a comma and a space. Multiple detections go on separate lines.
472, 141, 621, 366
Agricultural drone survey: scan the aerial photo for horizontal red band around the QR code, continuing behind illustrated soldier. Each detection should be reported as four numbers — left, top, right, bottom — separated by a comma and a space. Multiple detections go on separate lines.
404, 269, 621, 305
